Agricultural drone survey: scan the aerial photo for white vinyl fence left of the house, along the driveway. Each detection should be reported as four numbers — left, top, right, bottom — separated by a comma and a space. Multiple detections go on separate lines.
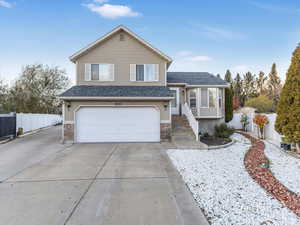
17, 113, 62, 133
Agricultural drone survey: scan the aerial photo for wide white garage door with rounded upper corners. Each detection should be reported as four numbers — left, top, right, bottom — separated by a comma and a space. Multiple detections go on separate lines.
75, 107, 160, 142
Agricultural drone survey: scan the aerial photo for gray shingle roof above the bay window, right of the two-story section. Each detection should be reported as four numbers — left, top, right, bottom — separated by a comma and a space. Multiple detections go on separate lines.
167, 72, 227, 85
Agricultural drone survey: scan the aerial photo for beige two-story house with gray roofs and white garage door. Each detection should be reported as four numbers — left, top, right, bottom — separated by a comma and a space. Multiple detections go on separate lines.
60, 26, 227, 142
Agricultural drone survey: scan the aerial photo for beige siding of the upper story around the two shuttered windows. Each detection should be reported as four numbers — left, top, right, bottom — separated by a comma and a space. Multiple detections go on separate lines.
77, 32, 166, 86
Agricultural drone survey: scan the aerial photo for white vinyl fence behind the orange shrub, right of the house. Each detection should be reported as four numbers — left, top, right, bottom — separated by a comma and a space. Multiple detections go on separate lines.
227, 113, 282, 146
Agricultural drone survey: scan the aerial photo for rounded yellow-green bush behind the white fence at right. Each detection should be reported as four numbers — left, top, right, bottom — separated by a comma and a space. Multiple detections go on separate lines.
245, 95, 274, 113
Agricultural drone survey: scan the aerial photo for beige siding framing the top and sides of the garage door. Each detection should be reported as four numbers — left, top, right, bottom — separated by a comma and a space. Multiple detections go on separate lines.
64, 101, 171, 121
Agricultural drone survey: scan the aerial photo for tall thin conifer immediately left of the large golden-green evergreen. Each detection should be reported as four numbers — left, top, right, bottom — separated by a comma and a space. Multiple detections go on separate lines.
268, 63, 281, 107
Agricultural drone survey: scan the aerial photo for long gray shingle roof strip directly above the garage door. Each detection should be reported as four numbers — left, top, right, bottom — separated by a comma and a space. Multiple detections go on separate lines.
60, 85, 172, 97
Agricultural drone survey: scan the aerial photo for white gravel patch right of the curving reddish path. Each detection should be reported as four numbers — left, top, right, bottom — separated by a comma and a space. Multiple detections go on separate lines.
265, 142, 300, 195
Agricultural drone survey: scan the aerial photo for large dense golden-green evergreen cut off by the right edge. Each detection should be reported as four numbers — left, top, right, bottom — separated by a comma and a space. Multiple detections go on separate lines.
275, 44, 300, 153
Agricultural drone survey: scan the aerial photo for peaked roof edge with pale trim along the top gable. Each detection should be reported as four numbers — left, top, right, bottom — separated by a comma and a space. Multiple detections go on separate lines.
70, 26, 172, 65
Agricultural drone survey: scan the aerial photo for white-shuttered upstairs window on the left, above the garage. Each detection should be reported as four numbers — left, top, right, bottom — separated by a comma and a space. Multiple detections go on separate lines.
85, 64, 114, 81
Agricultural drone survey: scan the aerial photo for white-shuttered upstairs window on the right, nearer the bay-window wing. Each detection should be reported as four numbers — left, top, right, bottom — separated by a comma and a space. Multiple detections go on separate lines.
130, 64, 159, 81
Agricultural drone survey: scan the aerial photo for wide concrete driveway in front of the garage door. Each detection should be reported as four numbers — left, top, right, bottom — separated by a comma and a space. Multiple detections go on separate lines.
0, 127, 208, 225
